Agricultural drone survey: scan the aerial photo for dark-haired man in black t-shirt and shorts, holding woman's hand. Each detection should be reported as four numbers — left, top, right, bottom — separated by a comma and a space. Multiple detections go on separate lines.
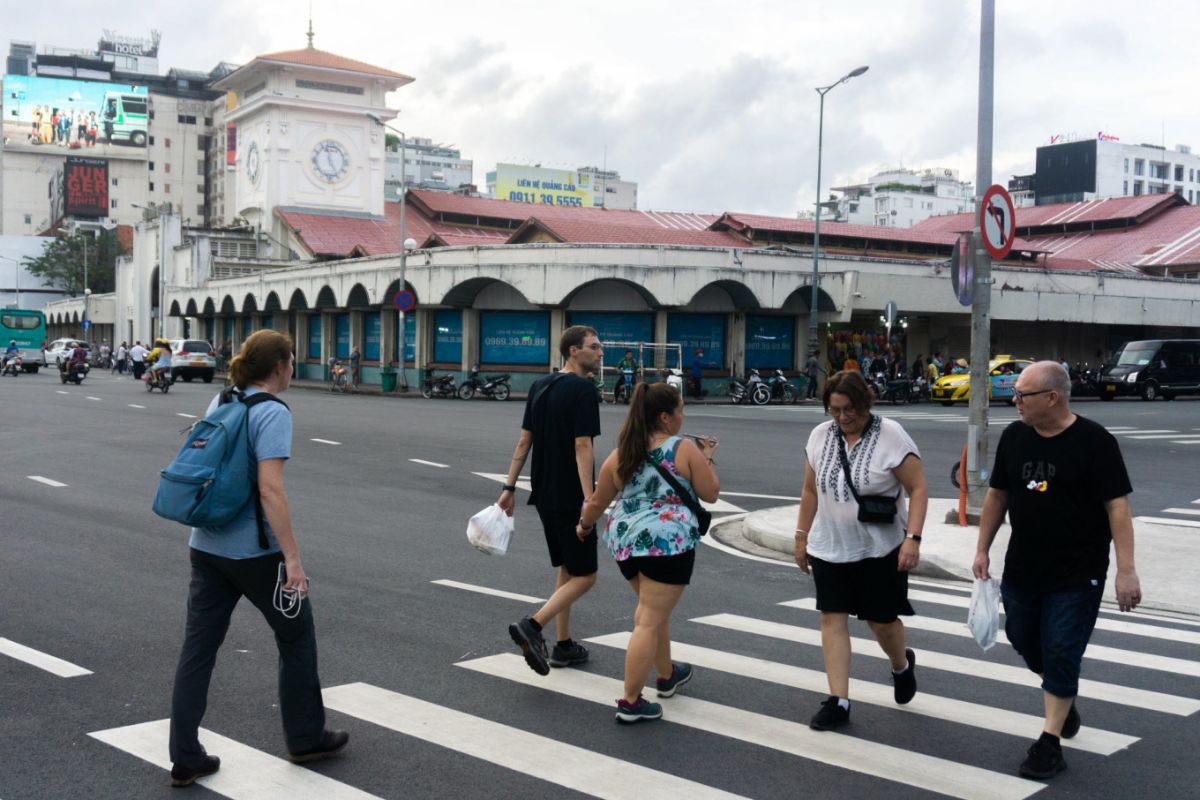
497, 325, 604, 675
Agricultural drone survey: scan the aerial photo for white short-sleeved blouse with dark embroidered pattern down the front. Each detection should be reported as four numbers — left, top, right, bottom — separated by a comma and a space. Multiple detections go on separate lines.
805, 415, 920, 564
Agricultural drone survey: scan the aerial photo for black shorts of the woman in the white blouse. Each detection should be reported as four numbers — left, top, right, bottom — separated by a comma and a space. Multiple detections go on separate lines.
809, 547, 916, 624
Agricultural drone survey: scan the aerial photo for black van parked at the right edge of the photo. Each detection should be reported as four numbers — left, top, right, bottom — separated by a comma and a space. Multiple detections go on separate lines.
1096, 339, 1200, 401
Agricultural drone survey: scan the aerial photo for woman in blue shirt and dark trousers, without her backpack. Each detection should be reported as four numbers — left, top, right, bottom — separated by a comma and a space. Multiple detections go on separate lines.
170, 330, 349, 786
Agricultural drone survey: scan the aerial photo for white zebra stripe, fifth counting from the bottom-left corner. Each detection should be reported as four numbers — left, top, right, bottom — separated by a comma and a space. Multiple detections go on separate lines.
690, 614, 1200, 717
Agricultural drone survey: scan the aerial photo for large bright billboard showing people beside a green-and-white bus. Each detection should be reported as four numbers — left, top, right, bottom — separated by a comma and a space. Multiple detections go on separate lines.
0, 76, 150, 158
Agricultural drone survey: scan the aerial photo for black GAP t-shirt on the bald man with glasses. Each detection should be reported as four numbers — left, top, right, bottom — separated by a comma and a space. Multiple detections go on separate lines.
990, 416, 1133, 591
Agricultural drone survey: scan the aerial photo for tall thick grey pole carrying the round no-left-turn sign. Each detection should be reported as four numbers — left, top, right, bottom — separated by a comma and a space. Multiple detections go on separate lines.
967, 0, 996, 513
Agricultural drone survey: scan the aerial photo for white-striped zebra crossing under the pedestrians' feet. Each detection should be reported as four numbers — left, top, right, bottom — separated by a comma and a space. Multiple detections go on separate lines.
90, 581, 1200, 800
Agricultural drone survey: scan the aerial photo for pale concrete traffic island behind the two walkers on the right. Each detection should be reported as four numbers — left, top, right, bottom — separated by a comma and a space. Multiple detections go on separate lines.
740, 499, 1200, 615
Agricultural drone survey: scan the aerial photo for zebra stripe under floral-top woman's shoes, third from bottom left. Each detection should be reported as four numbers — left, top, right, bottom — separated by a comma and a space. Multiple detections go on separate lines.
455, 654, 1044, 800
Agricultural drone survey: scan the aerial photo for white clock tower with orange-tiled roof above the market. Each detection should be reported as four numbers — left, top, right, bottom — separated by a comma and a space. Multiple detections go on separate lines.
214, 40, 413, 247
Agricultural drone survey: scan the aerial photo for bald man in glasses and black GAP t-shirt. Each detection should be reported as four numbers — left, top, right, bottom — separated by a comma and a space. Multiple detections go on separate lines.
972, 361, 1141, 778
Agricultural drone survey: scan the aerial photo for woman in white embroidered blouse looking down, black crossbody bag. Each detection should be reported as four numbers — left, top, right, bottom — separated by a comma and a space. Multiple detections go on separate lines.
796, 372, 929, 730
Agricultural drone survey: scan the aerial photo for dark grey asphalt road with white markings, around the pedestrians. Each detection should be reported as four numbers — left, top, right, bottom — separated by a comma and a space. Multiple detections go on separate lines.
0, 373, 1200, 800
